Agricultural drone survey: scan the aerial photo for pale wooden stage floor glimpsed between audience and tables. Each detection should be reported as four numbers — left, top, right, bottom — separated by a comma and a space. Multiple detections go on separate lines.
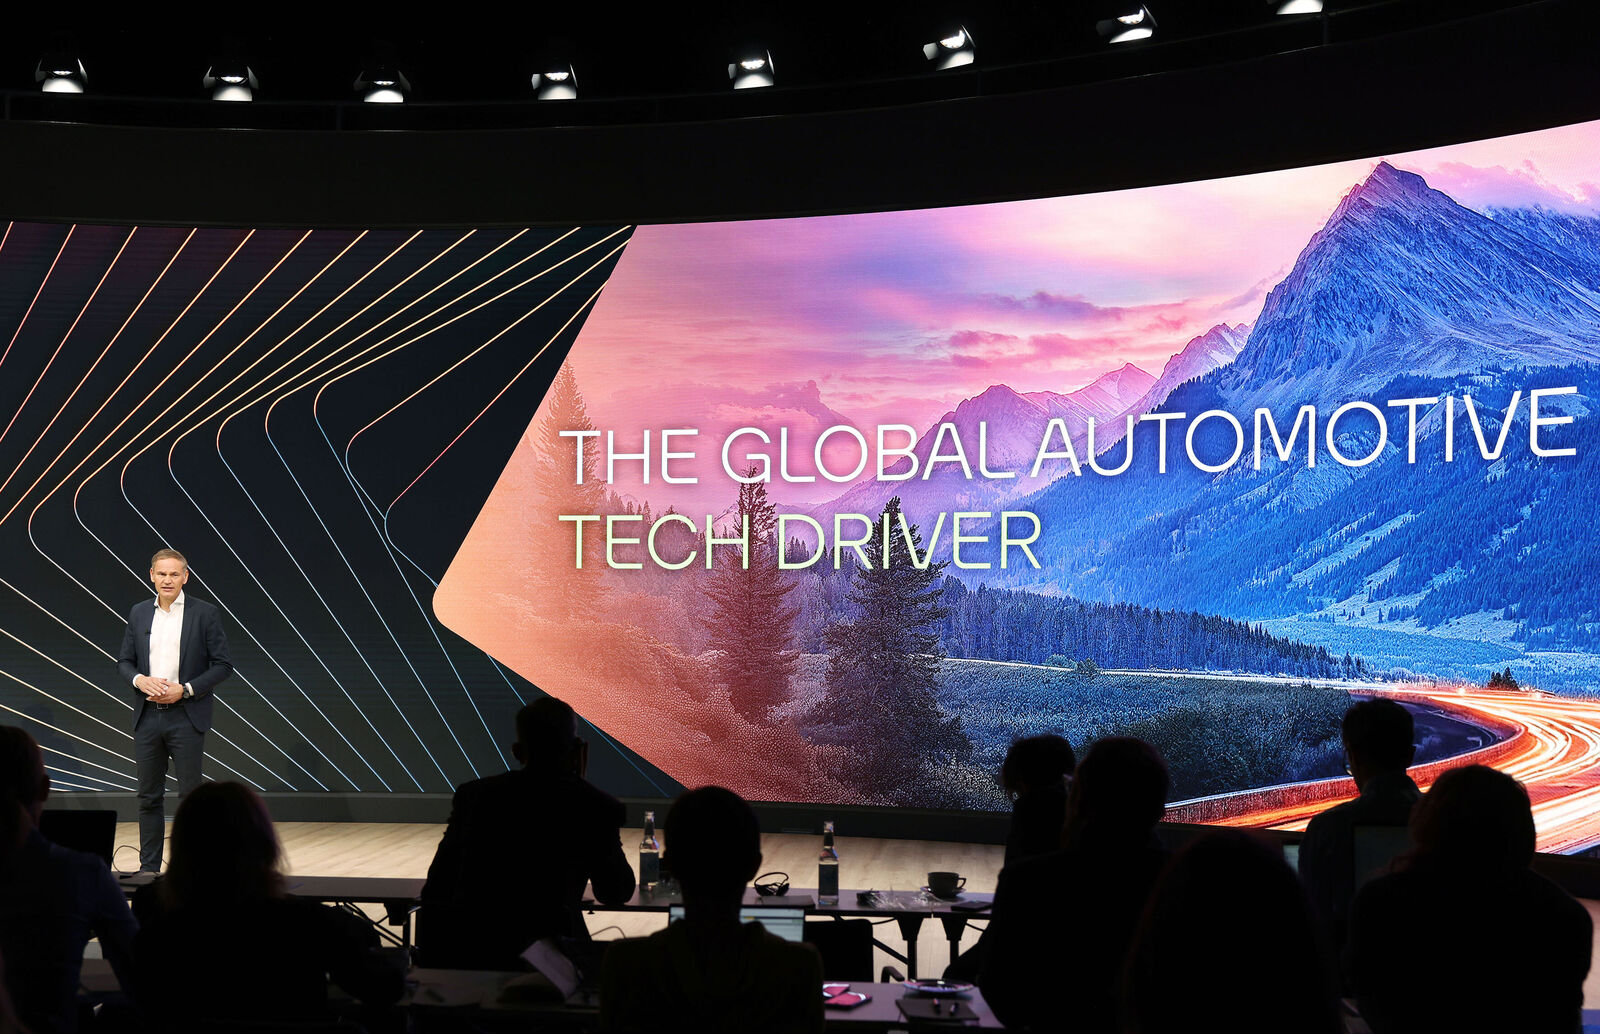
115, 823, 1005, 976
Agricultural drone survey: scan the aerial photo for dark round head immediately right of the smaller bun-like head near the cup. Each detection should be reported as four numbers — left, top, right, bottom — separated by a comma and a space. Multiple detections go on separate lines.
1064, 736, 1168, 842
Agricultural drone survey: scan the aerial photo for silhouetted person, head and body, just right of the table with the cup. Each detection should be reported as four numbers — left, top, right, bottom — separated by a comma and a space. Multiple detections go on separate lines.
979, 736, 1168, 1032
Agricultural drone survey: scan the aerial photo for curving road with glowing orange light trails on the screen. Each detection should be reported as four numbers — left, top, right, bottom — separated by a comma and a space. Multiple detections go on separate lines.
1196, 688, 1600, 853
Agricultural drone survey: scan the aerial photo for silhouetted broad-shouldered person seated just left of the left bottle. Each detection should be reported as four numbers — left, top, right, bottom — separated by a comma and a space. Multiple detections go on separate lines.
418, 696, 634, 970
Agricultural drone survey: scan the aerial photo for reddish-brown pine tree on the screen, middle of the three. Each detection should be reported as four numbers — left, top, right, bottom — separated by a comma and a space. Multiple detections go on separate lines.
704, 469, 800, 722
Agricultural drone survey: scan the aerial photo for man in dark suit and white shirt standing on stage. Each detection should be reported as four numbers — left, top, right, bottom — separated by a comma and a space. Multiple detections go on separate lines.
117, 549, 234, 872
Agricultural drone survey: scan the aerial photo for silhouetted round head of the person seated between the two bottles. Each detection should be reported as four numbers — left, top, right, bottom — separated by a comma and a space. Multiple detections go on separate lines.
664, 786, 762, 909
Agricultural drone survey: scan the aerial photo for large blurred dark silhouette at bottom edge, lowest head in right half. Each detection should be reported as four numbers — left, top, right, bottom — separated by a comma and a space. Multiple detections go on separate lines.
1123, 829, 1344, 1034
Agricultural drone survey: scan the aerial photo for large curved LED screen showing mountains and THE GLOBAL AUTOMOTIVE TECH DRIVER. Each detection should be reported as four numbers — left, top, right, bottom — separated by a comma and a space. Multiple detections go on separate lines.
0, 125, 1600, 852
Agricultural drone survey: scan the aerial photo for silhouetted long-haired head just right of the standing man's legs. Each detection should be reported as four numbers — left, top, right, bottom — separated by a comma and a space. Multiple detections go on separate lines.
162, 783, 283, 906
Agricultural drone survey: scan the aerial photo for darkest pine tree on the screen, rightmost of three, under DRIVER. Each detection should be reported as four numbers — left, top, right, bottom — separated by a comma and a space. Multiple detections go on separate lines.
818, 496, 971, 800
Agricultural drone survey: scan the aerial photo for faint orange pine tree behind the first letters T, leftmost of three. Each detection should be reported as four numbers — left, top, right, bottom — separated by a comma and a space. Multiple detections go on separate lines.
528, 363, 606, 618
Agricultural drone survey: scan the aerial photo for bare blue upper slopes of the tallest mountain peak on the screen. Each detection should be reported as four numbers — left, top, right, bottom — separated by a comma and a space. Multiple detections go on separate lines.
1219, 162, 1600, 410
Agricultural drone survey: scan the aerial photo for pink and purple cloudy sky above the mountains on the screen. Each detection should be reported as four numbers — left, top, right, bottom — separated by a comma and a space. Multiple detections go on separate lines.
570, 123, 1600, 515
